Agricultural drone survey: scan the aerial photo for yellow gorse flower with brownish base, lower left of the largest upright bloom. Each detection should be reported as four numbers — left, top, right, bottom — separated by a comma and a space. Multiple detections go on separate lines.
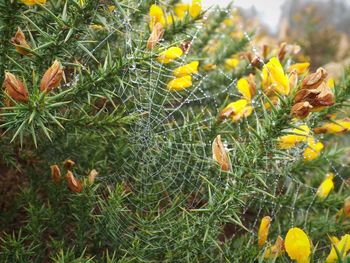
220, 99, 253, 122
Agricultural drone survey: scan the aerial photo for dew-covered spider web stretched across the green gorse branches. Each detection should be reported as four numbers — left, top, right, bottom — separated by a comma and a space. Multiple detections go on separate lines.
87, 1, 344, 261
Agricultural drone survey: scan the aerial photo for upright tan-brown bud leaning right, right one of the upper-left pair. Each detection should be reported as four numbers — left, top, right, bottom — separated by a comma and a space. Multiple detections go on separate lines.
40, 60, 63, 92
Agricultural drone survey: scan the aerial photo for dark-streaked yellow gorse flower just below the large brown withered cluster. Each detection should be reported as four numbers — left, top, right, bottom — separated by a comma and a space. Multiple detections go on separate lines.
278, 125, 310, 149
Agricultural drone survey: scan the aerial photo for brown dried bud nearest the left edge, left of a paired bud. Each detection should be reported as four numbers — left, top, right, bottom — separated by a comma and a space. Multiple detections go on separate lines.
2, 72, 29, 102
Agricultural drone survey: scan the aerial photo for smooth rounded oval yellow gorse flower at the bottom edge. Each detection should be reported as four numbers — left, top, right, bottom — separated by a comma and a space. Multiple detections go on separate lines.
284, 227, 311, 263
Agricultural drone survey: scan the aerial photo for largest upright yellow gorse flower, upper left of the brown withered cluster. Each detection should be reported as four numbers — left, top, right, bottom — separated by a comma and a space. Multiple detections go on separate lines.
262, 57, 290, 95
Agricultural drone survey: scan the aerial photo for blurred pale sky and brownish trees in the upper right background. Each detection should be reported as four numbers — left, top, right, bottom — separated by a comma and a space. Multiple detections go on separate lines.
186, 0, 350, 73
